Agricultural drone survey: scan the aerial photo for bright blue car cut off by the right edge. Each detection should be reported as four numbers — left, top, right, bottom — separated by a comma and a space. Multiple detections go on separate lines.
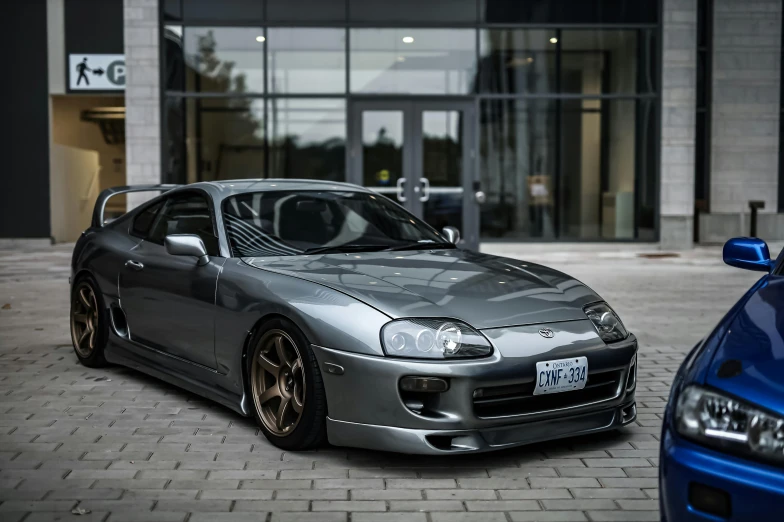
659, 238, 784, 522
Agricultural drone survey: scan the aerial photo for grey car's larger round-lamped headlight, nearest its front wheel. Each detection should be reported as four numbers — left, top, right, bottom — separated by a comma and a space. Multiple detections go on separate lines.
381, 319, 493, 359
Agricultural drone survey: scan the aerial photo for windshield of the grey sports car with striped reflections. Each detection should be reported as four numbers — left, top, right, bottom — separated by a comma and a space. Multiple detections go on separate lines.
223, 191, 454, 257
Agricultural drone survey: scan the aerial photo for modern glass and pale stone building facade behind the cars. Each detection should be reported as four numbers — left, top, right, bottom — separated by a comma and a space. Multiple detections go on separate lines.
0, 0, 784, 249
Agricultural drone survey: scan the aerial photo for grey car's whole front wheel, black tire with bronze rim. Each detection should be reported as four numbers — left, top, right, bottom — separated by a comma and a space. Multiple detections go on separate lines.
248, 319, 327, 450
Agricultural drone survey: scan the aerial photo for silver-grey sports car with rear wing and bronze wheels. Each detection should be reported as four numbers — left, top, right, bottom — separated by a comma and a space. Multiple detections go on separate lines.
70, 179, 637, 454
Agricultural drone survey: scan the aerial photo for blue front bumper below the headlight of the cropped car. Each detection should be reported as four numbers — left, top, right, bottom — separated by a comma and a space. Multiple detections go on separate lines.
660, 429, 784, 522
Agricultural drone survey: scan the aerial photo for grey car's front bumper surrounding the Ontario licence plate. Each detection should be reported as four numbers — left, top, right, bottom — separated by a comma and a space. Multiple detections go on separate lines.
312, 320, 637, 454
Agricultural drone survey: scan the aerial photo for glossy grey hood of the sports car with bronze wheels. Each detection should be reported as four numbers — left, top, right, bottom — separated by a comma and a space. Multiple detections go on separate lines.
243, 249, 600, 329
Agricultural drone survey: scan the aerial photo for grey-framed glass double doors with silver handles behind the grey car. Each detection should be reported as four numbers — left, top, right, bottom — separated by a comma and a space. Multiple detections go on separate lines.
349, 101, 481, 248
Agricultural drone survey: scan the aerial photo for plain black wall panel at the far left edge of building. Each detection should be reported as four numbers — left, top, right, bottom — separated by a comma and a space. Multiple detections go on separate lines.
0, 0, 51, 238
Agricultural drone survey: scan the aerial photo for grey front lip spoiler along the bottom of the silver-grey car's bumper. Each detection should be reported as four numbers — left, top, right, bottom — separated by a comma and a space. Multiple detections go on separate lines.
327, 400, 637, 455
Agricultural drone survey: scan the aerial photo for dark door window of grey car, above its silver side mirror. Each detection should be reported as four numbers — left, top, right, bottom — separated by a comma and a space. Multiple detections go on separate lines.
147, 194, 219, 256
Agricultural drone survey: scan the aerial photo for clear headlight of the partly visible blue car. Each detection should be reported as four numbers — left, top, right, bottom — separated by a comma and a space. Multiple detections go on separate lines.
675, 386, 784, 465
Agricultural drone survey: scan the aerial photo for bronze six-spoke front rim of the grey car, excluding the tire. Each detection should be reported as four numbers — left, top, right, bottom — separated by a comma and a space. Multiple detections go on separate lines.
250, 329, 307, 437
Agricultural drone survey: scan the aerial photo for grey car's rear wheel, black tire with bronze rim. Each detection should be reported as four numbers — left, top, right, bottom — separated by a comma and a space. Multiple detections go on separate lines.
70, 276, 109, 368
